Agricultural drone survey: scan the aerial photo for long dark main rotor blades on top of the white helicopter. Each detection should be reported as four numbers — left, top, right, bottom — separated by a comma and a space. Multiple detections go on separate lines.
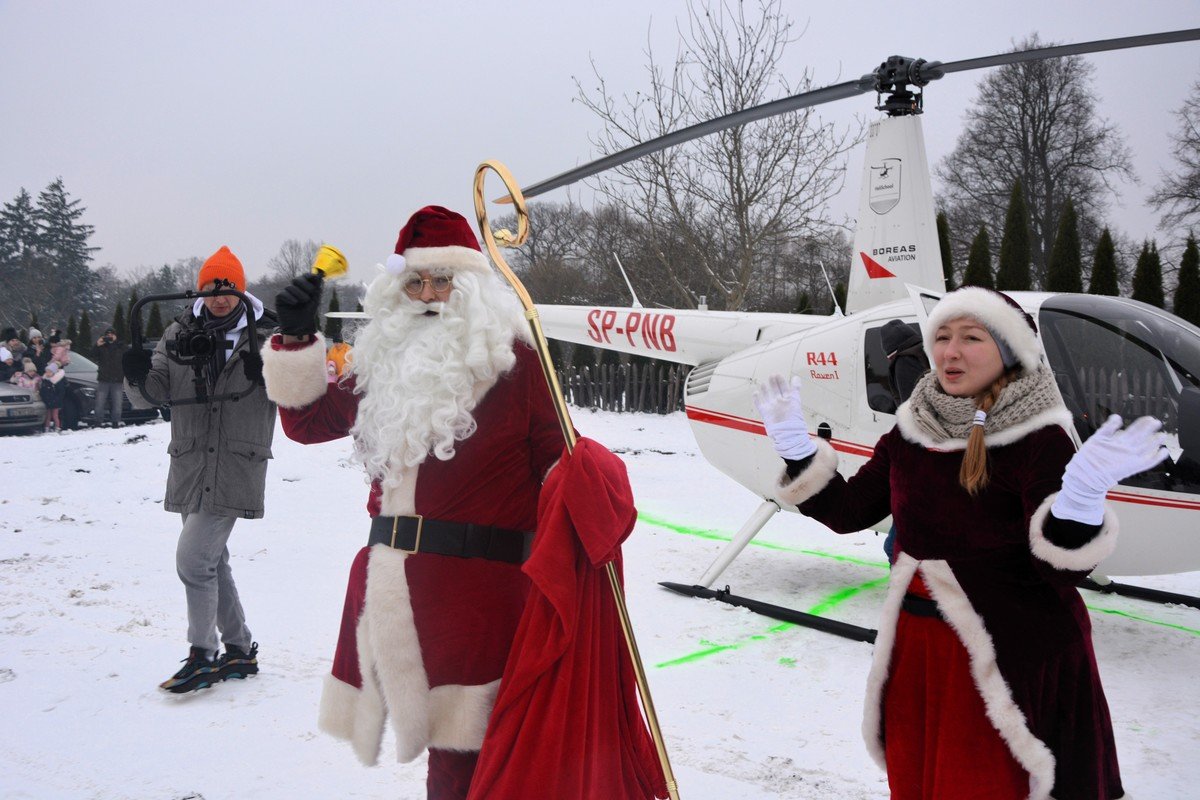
516, 28, 1200, 203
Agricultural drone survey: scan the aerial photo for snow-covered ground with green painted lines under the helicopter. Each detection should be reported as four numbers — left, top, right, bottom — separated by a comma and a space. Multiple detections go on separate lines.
0, 411, 1200, 800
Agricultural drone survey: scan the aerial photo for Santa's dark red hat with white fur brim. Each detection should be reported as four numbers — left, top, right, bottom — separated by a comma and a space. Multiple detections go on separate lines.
388, 205, 491, 275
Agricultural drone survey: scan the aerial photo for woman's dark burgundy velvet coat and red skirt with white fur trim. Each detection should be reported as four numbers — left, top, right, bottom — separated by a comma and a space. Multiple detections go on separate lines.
779, 415, 1123, 800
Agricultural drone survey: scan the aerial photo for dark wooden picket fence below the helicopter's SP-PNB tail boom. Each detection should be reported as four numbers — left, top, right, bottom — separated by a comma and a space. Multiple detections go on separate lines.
558, 361, 689, 414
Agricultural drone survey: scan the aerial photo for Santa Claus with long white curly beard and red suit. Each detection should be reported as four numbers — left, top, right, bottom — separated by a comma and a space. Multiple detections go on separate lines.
263, 206, 564, 798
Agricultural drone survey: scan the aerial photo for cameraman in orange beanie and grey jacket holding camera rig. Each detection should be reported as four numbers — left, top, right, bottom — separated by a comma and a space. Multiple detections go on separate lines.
124, 247, 275, 693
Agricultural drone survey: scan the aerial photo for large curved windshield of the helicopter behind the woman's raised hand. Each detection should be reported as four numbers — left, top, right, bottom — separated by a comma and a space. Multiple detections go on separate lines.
1038, 295, 1200, 493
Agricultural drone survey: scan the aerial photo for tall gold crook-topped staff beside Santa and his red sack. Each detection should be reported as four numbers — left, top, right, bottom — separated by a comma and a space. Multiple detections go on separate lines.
475, 161, 679, 800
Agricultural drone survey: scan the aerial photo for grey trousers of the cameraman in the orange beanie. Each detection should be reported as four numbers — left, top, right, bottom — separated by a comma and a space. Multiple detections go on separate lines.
175, 511, 252, 654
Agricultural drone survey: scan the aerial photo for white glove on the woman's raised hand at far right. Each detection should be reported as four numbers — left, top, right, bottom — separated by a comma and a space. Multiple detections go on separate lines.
1050, 414, 1169, 525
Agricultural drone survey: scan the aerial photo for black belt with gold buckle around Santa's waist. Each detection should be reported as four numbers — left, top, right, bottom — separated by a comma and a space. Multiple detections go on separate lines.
367, 515, 533, 564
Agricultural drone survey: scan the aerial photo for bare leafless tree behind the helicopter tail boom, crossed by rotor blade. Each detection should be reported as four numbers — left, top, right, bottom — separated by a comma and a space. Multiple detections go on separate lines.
576, 0, 862, 309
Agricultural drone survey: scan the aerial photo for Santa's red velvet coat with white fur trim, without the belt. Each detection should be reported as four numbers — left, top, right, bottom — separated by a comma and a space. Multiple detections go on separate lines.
271, 343, 563, 777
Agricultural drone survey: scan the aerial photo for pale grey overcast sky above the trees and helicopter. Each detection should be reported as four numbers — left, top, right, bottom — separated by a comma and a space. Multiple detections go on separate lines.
0, 0, 1200, 291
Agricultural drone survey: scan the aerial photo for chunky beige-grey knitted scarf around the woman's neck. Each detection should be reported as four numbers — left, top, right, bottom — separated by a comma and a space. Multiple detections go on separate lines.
908, 365, 1062, 443
